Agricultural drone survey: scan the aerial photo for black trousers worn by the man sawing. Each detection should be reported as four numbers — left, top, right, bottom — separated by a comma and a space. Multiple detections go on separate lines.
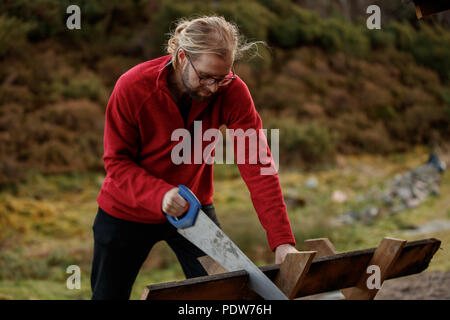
91, 204, 220, 300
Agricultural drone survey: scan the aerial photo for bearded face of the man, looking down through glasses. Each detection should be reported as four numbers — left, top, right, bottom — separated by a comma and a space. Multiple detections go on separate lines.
181, 53, 232, 101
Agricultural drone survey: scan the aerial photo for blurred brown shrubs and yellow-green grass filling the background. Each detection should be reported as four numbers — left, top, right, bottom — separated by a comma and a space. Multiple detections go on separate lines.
0, 0, 450, 299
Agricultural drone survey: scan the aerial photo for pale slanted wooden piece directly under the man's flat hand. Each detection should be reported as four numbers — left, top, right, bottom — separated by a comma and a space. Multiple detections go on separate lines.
274, 251, 317, 299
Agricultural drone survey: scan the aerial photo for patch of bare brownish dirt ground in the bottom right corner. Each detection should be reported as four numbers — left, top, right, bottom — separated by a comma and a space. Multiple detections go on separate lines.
375, 272, 450, 300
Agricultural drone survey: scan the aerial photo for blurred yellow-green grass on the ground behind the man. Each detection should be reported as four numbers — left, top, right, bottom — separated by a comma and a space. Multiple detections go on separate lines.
0, 148, 450, 299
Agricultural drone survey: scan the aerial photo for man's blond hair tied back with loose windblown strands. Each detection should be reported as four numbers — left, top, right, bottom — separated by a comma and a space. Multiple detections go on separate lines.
166, 16, 265, 68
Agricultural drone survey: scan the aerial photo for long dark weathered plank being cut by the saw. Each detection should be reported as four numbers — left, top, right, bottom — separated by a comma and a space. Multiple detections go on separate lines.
143, 238, 441, 300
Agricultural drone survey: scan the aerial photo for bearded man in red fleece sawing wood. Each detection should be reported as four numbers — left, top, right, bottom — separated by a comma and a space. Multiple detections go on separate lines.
91, 17, 297, 299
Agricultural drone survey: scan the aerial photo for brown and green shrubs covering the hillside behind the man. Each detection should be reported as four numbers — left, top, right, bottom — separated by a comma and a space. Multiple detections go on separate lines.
0, 0, 450, 182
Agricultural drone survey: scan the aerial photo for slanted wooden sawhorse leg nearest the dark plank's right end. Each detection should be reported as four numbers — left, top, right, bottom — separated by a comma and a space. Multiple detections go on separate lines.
346, 237, 406, 300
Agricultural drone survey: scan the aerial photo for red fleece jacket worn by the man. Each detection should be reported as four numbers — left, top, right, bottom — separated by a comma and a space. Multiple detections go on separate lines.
97, 55, 295, 251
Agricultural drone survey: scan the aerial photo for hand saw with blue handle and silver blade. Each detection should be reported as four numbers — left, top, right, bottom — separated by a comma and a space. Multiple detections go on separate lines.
166, 185, 288, 300
